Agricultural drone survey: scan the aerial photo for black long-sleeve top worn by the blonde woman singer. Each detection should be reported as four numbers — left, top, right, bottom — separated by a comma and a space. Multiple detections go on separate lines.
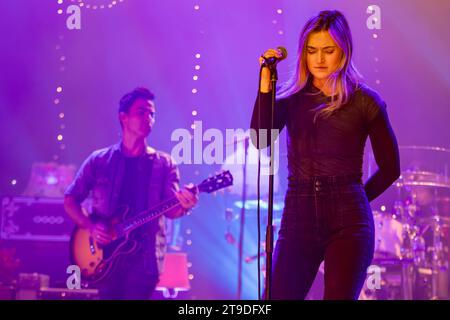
251, 82, 400, 201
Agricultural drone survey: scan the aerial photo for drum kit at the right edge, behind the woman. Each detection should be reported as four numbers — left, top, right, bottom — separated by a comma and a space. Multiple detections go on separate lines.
362, 146, 450, 300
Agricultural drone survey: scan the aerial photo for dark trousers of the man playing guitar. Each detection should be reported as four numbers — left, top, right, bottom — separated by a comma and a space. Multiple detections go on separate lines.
98, 253, 159, 300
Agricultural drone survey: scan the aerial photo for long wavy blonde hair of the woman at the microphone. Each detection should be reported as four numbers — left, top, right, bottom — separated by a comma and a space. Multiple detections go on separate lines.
277, 10, 362, 120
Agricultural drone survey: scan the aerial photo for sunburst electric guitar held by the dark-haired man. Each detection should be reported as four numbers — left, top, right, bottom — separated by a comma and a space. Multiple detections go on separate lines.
70, 171, 233, 284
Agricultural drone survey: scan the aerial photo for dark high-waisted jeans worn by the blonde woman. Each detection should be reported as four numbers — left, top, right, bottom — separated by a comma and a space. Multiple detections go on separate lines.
272, 176, 375, 300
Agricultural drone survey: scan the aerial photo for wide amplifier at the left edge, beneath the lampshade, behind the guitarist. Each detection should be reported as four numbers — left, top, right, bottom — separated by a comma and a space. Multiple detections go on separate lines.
0, 197, 75, 242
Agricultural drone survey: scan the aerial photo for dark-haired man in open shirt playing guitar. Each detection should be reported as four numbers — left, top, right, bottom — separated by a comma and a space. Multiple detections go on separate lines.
64, 88, 198, 300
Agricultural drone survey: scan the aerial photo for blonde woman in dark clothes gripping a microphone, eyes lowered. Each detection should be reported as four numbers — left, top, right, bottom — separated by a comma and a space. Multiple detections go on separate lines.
251, 11, 400, 299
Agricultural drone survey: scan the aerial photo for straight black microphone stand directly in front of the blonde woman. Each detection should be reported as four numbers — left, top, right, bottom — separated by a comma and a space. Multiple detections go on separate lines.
264, 64, 278, 300
